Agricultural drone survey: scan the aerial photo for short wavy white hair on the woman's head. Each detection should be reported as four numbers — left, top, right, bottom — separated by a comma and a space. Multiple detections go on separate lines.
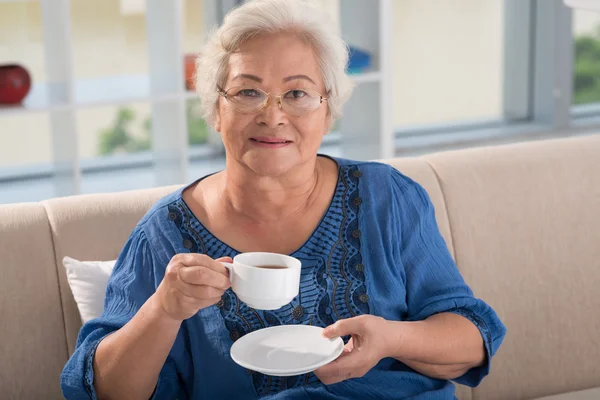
195, 0, 353, 126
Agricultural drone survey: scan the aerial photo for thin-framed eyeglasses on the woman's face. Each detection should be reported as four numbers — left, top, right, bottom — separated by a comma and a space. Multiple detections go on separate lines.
218, 86, 327, 117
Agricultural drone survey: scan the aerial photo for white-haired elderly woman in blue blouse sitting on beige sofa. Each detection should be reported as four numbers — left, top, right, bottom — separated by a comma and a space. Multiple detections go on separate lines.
62, 0, 505, 399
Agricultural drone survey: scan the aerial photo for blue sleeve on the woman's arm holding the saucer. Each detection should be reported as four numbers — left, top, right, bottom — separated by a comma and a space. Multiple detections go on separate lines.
392, 171, 506, 387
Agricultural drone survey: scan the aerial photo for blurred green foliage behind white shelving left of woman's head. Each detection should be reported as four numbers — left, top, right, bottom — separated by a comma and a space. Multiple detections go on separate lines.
98, 99, 209, 155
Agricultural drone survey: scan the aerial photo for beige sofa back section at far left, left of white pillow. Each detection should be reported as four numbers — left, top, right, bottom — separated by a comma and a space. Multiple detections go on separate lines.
0, 204, 68, 399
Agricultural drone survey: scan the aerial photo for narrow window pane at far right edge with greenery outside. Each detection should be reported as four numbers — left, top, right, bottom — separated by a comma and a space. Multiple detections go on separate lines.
573, 10, 600, 104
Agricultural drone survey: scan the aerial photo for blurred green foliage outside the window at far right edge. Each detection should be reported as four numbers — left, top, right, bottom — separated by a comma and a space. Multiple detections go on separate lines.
573, 25, 600, 104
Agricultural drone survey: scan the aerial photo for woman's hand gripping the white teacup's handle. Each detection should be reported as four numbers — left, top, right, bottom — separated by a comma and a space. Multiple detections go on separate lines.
156, 253, 232, 321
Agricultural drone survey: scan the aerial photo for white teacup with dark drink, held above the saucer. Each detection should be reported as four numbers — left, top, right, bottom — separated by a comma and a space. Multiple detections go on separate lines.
222, 252, 302, 310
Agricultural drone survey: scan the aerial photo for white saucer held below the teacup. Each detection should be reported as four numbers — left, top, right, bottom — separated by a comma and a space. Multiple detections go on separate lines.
230, 325, 344, 376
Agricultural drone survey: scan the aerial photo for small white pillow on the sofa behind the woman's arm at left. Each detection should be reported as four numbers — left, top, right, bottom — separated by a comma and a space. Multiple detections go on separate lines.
63, 257, 116, 323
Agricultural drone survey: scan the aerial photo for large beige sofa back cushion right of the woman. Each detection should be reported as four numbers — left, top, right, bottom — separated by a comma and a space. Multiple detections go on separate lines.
426, 135, 600, 400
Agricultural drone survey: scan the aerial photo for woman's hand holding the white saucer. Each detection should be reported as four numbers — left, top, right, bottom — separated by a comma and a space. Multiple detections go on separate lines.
315, 315, 388, 385
